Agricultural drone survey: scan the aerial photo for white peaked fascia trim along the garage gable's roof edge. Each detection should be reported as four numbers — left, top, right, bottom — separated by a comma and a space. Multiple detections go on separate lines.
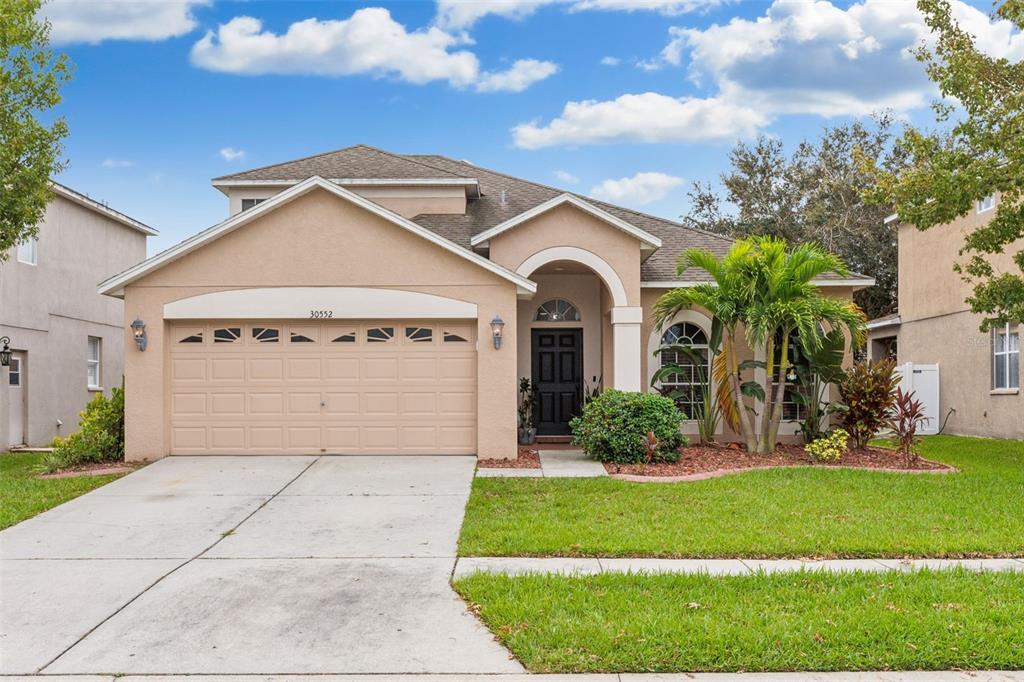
98, 176, 537, 296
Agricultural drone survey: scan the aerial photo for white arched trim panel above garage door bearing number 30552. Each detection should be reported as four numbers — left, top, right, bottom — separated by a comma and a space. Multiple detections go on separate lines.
164, 287, 477, 319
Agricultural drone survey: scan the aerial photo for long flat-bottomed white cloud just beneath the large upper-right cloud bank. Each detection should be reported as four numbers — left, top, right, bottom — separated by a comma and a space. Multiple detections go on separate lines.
512, 92, 768, 150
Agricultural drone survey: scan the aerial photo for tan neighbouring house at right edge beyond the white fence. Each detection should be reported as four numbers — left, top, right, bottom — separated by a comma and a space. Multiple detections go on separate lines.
867, 196, 1024, 438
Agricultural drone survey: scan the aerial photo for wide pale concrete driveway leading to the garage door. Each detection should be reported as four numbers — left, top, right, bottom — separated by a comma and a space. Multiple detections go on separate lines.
0, 457, 522, 674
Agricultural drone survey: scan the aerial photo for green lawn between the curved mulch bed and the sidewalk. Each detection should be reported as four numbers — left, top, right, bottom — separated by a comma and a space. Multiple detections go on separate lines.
460, 436, 1024, 558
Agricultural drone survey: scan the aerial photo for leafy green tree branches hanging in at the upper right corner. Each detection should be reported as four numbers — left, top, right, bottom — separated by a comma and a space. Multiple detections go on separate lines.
862, 0, 1024, 331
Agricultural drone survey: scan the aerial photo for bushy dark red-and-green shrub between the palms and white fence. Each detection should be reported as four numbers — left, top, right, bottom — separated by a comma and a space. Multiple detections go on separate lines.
839, 359, 899, 447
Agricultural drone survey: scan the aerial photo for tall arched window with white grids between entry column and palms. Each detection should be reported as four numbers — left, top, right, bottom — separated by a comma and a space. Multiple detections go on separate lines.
658, 323, 711, 419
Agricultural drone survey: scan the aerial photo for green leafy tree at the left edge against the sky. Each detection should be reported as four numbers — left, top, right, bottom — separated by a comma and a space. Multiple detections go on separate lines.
0, 0, 71, 262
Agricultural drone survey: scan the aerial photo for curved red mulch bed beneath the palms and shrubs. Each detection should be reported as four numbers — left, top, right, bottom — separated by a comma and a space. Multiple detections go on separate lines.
604, 444, 956, 480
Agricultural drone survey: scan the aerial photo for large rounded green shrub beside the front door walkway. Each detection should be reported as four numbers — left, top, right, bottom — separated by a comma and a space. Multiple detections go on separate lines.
569, 389, 686, 464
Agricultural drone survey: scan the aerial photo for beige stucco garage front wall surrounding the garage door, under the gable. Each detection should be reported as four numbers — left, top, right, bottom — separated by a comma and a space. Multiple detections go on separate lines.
125, 189, 517, 460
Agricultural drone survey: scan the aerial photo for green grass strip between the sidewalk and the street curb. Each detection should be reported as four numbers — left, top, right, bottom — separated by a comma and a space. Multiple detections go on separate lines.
456, 570, 1024, 673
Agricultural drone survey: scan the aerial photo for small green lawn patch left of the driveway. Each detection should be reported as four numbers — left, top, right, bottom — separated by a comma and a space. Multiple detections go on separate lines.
0, 453, 123, 528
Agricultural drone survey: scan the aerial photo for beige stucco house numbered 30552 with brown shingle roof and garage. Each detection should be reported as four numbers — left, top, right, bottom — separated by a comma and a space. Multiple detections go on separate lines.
99, 145, 871, 460
